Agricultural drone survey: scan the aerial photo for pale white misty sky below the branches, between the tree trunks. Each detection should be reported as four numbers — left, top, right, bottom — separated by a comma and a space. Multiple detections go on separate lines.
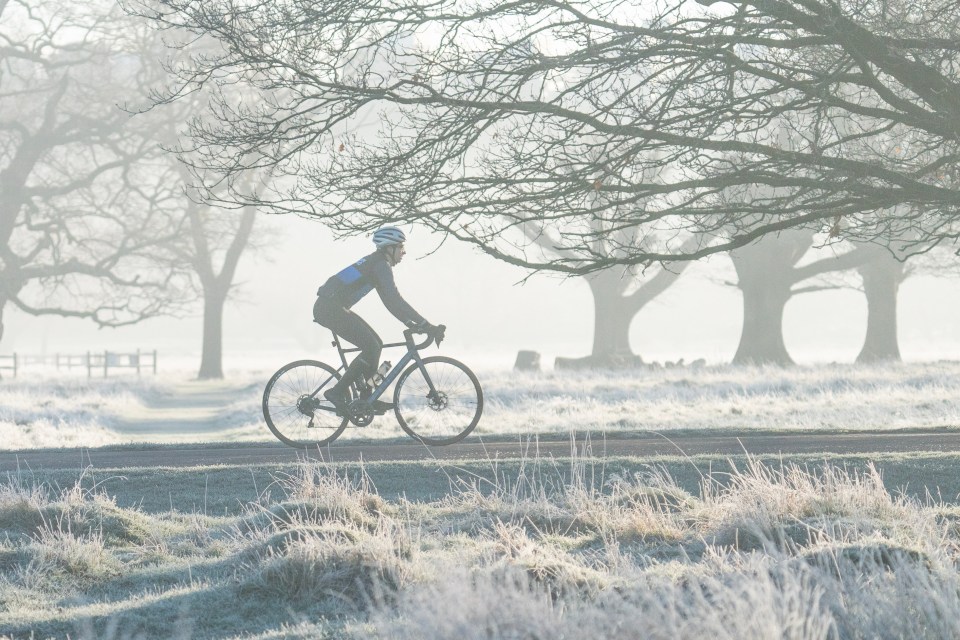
7, 217, 960, 372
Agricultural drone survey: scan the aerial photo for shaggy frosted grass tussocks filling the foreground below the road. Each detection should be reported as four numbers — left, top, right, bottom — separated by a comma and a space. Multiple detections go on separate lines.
0, 459, 960, 640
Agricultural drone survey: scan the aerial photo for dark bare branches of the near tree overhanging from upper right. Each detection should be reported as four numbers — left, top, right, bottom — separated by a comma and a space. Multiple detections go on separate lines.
131, 0, 960, 274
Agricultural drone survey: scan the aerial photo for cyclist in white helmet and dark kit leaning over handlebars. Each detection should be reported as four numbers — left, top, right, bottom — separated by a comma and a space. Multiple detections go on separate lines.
313, 227, 437, 415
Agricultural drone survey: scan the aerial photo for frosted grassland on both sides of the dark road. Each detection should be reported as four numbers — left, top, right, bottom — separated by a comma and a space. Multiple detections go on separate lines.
0, 362, 960, 640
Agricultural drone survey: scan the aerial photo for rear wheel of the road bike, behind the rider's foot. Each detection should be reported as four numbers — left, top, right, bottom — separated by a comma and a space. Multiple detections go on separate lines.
263, 360, 347, 449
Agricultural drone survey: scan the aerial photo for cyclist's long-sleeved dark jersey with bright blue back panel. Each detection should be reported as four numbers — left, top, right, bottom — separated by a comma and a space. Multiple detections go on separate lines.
317, 251, 426, 326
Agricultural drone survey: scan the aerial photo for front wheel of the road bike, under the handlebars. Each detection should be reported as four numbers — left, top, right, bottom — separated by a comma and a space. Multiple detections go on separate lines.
393, 356, 483, 445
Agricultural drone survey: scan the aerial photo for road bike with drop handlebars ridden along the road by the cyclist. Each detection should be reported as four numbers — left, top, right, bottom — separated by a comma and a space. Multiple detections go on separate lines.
263, 325, 483, 448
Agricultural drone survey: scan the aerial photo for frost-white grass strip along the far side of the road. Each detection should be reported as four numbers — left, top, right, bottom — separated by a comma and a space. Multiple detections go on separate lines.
0, 362, 960, 449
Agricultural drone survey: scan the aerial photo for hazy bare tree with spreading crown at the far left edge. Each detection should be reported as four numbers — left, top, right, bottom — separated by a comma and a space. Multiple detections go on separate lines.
0, 0, 186, 342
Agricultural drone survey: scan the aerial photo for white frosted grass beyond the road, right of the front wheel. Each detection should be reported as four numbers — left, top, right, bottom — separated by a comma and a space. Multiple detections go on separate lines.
492, 362, 960, 433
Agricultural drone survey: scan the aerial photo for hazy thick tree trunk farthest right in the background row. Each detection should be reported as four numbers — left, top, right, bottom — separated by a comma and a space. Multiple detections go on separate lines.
857, 254, 904, 363
